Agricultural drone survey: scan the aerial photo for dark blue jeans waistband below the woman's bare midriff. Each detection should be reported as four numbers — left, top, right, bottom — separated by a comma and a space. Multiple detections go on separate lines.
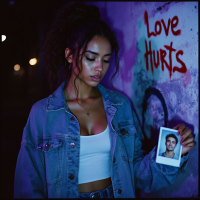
79, 185, 114, 198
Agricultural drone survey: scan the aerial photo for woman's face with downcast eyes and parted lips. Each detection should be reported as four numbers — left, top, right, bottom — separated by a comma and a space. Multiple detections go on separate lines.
72, 36, 111, 87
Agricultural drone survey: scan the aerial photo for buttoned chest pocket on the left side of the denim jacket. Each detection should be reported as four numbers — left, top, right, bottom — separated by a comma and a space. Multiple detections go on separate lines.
37, 138, 63, 184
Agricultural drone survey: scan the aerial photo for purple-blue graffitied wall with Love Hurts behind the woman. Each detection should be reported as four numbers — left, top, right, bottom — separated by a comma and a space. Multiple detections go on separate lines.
88, 2, 199, 197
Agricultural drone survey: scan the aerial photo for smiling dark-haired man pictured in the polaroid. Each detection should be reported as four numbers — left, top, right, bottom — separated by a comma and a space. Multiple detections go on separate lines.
159, 133, 179, 160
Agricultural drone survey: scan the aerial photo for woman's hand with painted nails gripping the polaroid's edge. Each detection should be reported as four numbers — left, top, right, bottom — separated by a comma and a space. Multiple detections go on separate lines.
173, 124, 196, 155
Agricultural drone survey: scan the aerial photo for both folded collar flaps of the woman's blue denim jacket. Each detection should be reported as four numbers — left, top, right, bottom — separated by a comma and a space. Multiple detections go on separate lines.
46, 81, 123, 111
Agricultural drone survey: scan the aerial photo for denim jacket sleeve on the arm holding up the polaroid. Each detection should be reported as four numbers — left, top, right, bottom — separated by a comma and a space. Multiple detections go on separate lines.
133, 112, 188, 193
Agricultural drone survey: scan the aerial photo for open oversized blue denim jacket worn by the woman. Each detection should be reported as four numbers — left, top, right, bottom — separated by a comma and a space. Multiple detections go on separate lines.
14, 82, 188, 198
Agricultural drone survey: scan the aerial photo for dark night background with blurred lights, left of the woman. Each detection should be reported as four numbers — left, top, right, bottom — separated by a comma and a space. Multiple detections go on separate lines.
0, 0, 71, 199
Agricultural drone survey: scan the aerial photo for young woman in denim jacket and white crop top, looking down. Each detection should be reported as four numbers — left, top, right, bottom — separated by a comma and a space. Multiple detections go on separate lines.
14, 3, 195, 198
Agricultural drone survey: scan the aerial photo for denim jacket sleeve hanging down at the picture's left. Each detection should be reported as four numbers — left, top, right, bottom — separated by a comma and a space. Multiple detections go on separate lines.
14, 113, 47, 198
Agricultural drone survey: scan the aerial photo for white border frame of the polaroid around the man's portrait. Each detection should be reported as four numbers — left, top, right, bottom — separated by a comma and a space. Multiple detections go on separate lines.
156, 127, 182, 167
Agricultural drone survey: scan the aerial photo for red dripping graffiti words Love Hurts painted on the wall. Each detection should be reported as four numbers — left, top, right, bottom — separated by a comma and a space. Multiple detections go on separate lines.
144, 11, 187, 79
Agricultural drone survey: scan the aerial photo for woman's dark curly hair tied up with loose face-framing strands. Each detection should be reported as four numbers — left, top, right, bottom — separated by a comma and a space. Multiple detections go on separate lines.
43, 2, 120, 95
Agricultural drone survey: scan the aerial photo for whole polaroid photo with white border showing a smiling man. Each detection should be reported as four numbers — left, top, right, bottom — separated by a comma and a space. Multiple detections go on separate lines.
156, 127, 182, 167
